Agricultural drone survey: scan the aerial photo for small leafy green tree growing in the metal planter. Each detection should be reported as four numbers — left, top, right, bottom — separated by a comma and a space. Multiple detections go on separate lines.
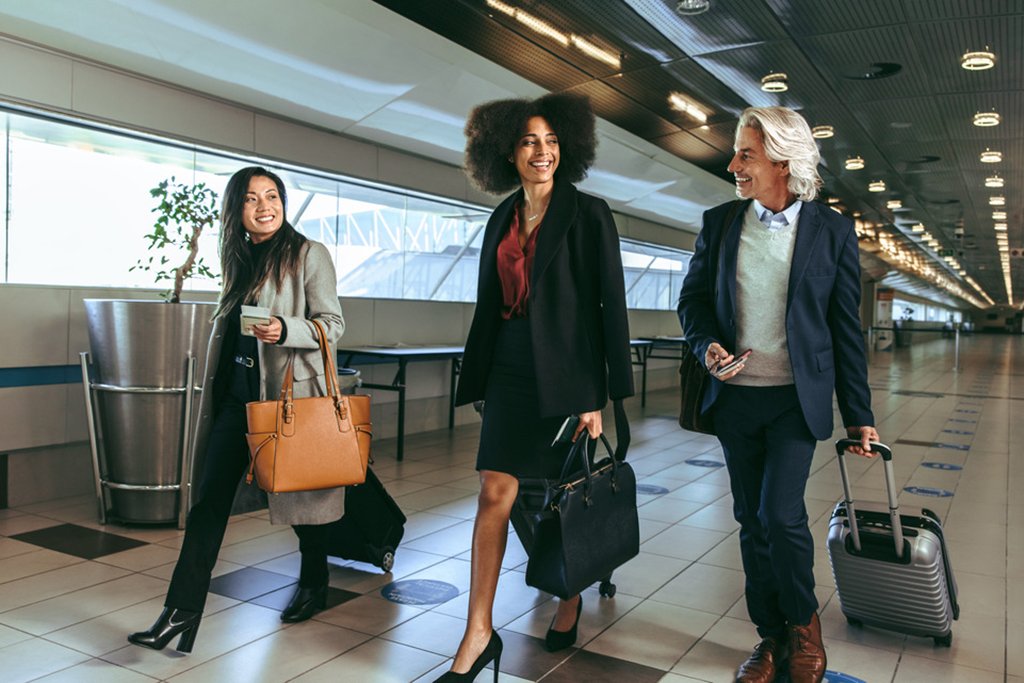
129, 176, 220, 303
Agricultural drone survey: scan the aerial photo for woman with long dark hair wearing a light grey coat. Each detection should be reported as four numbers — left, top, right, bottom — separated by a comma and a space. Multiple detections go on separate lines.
128, 166, 345, 652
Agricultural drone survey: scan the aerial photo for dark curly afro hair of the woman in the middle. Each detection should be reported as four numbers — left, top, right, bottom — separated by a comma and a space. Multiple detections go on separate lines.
466, 92, 597, 195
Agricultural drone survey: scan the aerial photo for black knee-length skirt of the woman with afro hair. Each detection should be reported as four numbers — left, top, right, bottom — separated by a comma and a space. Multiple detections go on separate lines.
476, 317, 568, 479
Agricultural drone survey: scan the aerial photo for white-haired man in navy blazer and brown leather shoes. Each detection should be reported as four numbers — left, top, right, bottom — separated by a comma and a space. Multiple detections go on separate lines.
677, 106, 879, 683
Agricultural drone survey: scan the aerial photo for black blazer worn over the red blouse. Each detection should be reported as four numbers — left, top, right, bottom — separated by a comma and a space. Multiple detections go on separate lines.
456, 180, 633, 417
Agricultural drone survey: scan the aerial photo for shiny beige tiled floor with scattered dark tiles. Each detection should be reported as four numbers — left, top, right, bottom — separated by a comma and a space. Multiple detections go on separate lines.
0, 336, 1024, 683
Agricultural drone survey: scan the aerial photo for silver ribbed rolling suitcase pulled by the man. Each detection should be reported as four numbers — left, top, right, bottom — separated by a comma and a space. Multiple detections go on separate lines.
828, 439, 959, 647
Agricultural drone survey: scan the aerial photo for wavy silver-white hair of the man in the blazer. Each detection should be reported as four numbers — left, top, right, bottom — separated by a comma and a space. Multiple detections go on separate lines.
736, 106, 821, 202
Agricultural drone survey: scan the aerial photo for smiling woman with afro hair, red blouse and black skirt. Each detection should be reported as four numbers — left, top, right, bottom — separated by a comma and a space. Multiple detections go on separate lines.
438, 93, 633, 681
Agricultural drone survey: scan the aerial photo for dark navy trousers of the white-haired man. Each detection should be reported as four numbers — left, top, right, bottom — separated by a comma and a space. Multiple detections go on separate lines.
714, 384, 818, 637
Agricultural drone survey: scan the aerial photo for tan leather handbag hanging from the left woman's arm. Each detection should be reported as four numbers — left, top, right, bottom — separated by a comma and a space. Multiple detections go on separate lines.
246, 321, 373, 494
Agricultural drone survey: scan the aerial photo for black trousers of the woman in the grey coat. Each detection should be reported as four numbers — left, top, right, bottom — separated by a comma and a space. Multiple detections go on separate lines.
164, 401, 328, 611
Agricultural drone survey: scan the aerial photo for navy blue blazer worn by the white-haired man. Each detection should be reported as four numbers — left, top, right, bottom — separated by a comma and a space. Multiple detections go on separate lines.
677, 202, 874, 440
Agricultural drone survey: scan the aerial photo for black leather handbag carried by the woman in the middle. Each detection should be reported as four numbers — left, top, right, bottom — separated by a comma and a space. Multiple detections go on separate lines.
526, 432, 640, 599
